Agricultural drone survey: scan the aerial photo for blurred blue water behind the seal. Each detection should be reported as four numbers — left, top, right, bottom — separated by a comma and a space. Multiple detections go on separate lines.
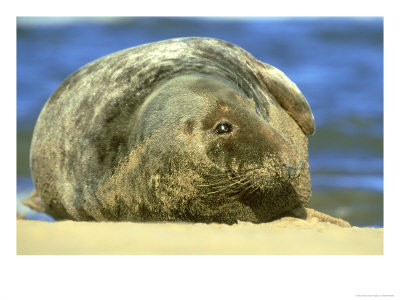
17, 18, 383, 226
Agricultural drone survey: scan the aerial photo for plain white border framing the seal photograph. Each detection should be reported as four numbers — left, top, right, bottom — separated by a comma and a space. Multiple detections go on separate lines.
0, 0, 400, 299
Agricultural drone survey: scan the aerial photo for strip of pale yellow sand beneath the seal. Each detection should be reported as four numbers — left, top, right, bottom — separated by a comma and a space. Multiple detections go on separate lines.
17, 217, 383, 255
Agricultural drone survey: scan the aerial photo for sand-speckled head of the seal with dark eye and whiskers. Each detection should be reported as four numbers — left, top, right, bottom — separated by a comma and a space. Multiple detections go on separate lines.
104, 75, 309, 223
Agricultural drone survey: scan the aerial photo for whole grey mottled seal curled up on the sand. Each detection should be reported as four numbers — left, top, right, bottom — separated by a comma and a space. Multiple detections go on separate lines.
31, 38, 314, 224
